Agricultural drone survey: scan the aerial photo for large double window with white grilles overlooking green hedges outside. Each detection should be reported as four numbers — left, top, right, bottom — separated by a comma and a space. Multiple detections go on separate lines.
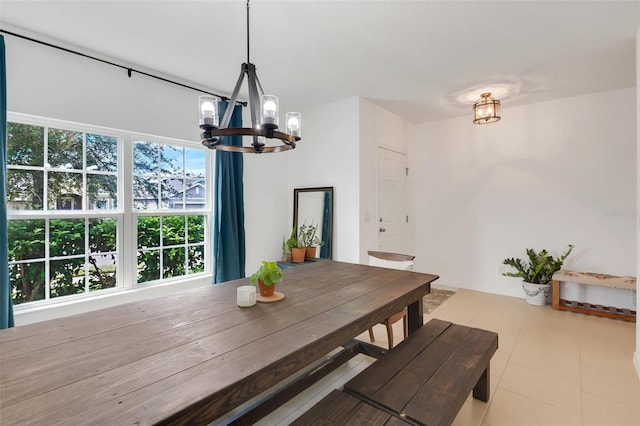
7, 115, 210, 304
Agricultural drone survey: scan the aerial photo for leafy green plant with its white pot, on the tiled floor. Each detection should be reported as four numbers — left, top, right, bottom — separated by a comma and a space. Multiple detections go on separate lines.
502, 244, 573, 306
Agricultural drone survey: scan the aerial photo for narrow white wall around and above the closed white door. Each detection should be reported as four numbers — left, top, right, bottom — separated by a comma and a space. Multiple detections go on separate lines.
359, 99, 414, 263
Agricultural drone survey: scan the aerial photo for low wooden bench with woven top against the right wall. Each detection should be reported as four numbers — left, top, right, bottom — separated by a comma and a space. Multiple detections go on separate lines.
551, 269, 636, 322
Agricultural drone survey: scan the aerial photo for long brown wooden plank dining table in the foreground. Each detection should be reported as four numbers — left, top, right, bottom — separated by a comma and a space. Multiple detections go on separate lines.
0, 261, 438, 426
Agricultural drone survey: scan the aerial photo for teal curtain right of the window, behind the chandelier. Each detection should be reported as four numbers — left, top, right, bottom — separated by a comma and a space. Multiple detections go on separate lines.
213, 102, 246, 283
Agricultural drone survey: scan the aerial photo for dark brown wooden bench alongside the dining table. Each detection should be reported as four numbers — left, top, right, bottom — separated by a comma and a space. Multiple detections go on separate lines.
294, 319, 498, 426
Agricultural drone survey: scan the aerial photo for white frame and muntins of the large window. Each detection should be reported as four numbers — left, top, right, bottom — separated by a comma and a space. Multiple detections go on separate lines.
7, 112, 214, 313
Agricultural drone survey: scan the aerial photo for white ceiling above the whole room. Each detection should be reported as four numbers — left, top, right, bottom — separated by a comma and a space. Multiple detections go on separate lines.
0, 0, 640, 123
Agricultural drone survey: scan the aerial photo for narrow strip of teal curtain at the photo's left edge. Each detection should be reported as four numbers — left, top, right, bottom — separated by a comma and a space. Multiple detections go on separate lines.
0, 36, 14, 329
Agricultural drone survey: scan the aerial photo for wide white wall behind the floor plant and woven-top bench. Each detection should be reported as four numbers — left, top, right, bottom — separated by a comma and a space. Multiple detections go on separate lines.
409, 88, 636, 307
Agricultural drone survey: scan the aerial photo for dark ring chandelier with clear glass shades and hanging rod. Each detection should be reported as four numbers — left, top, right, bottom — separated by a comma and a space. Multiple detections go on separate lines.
199, 0, 302, 154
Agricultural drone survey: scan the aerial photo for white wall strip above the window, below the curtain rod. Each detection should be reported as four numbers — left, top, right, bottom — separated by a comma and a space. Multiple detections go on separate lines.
5, 32, 200, 141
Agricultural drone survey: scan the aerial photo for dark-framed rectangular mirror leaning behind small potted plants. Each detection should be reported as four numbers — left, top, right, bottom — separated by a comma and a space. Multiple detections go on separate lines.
293, 186, 333, 259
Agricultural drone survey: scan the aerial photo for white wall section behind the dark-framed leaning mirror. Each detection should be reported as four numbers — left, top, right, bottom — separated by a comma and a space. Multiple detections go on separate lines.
288, 97, 360, 263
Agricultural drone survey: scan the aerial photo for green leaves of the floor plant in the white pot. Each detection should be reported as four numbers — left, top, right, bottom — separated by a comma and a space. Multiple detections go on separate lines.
502, 244, 573, 284
